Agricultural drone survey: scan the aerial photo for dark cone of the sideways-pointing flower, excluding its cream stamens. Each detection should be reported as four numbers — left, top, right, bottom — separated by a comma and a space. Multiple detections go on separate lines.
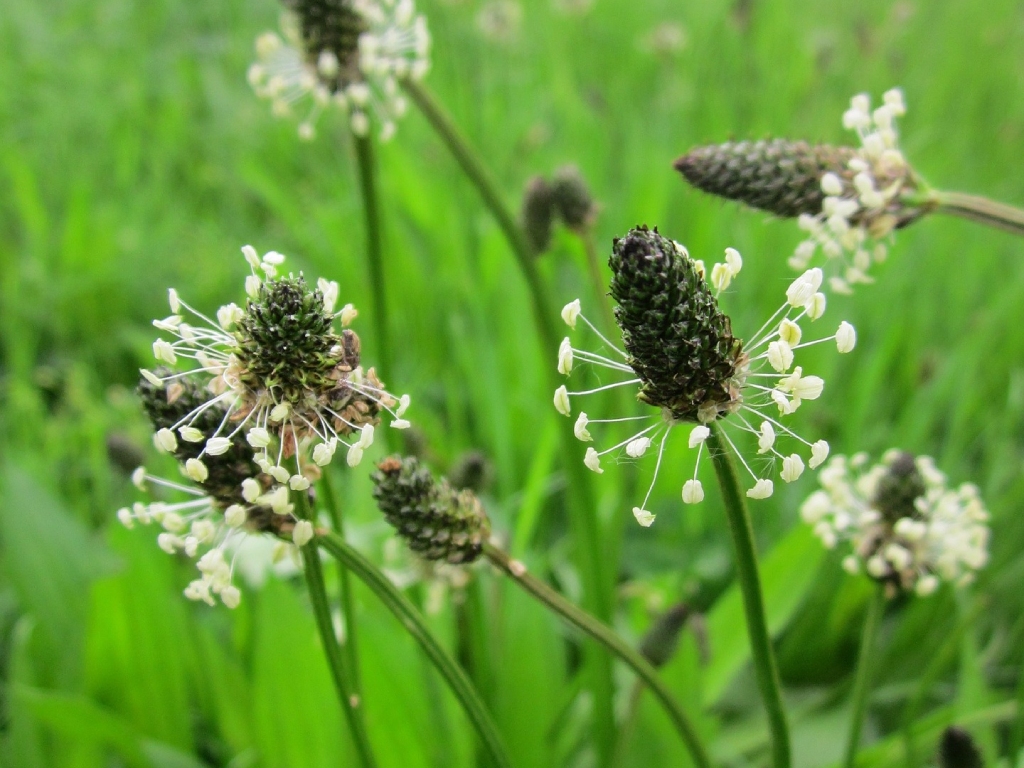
675, 138, 856, 218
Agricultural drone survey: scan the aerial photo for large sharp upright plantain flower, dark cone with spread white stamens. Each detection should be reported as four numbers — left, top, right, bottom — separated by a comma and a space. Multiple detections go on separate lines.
555, 226, 856, 525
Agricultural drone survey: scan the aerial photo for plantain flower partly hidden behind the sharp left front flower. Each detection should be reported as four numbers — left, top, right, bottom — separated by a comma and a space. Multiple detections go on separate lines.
118, 370, 309, 608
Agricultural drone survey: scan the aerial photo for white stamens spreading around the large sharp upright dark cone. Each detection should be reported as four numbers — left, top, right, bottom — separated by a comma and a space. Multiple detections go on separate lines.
554, 249, 856, 526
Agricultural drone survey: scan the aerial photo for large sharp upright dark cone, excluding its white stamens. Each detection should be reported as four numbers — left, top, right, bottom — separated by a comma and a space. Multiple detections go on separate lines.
608, 226, 745, 423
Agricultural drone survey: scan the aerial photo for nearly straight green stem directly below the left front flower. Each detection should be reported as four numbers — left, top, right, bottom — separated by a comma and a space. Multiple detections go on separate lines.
292, 490, 377, 768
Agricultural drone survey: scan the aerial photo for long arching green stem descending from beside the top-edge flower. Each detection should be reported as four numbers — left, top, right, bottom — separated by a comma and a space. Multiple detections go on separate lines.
402, 75, 614, 765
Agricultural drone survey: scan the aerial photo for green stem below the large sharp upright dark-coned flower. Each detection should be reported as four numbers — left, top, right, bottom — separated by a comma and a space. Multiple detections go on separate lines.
708, 423, 792, 768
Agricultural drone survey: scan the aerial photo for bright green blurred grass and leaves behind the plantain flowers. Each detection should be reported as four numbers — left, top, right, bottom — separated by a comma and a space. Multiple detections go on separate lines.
0, 0, 1024, 768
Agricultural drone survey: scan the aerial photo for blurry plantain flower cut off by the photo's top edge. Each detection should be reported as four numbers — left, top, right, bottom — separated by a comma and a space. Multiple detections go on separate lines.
249, 0, 430, 141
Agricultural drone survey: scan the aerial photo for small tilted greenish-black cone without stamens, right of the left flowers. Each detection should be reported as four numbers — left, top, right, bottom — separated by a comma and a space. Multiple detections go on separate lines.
371, 457, 490, 565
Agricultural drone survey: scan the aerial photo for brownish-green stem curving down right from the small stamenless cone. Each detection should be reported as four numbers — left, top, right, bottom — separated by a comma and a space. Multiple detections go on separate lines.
483, 544, 711, 768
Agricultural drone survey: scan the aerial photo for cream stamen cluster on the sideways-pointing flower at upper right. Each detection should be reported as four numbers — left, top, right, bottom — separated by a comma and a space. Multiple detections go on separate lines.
790, 88, 909, 294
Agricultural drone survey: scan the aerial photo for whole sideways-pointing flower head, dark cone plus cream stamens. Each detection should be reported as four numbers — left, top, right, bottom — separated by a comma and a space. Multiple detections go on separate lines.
676, 88, 936, 293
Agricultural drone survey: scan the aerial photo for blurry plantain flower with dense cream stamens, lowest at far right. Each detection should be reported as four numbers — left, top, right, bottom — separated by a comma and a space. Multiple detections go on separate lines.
800, 450, 989, 595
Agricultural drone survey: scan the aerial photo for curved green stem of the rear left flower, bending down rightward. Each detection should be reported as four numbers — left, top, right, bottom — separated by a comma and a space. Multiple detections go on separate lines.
315, 530, 512, 768
